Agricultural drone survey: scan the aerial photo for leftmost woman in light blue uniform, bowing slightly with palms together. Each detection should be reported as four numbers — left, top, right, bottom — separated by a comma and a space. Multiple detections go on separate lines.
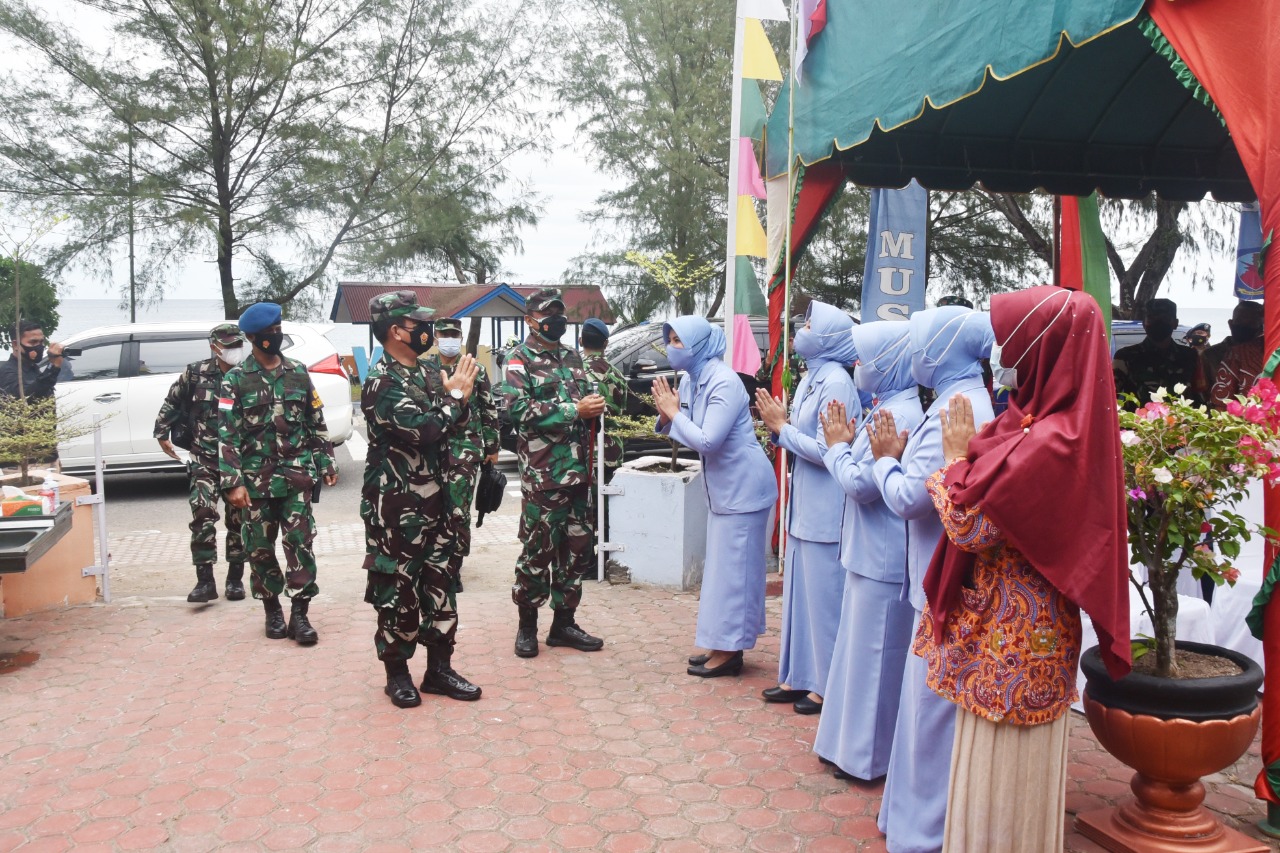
653, 316, 778, 678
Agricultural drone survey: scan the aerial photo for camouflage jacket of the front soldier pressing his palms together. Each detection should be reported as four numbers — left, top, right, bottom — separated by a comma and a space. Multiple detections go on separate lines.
360, 355, 470, 528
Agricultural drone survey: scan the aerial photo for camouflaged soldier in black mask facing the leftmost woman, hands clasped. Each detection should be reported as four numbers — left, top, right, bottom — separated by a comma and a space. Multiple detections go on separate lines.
503, 289, 604, 657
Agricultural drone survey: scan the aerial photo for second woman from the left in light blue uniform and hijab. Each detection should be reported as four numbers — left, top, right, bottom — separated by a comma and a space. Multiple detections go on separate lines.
755, 301, 861, 713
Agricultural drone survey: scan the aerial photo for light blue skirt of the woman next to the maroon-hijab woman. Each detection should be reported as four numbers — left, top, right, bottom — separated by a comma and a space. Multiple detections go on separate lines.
876, 611, 956, 853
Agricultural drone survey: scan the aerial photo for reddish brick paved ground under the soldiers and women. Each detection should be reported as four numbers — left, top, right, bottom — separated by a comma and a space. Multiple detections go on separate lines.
0, 571, 1261, 852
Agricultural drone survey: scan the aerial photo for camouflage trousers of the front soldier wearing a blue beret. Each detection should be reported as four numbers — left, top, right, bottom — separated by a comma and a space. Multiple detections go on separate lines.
244, 489, 320, 598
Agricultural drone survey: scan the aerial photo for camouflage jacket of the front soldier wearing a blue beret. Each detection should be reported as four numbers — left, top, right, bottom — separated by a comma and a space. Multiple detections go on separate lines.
218, 355, 335, 498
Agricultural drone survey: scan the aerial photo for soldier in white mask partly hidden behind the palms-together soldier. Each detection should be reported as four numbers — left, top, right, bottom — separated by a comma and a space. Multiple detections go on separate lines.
424, 318, 499, 592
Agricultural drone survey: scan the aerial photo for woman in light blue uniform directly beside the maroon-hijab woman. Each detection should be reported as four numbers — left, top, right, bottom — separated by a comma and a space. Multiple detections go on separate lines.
869, 306, 996, 853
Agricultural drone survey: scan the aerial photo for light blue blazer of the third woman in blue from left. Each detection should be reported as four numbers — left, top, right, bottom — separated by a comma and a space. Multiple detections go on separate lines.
826, 386, 936, 584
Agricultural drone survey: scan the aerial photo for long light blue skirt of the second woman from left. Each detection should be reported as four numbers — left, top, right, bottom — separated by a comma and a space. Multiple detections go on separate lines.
778, 535, 849, 695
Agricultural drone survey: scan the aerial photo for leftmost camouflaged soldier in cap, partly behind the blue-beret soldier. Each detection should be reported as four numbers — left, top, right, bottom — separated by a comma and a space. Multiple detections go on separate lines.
155, 323, 246, 602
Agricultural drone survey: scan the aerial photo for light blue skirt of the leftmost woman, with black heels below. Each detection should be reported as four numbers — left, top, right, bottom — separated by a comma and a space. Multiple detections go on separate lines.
694, 508, 769, 652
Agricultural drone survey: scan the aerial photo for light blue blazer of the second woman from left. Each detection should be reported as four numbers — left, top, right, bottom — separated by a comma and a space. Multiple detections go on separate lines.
773, 361, 861, 542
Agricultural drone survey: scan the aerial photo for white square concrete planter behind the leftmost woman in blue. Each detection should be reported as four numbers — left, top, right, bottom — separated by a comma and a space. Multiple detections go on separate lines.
609, 456, 707, 590
